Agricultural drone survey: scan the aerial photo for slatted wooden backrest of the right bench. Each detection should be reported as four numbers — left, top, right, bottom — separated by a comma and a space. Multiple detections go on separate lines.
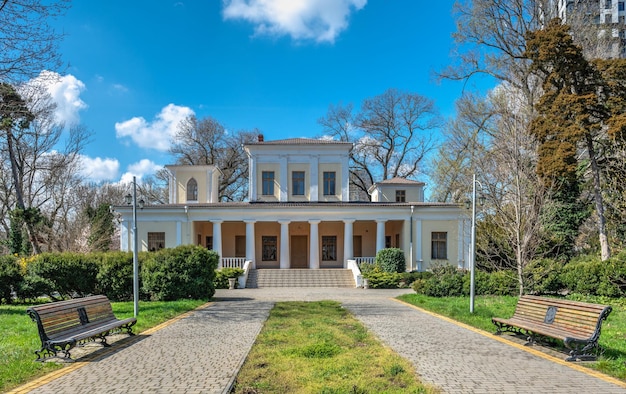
514, 295, 611, 337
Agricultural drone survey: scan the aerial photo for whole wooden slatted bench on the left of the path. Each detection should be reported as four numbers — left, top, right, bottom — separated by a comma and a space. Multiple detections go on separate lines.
26, 295, 137, 361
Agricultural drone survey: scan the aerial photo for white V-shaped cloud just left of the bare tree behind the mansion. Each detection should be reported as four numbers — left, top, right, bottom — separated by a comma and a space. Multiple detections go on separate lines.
115, 104, 194, 151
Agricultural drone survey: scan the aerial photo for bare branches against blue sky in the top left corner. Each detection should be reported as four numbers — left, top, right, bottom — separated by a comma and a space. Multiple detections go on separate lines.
0, 0, 70, 84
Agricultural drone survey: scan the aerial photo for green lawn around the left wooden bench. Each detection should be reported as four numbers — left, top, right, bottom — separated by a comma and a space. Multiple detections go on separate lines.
0, 300, 206, 392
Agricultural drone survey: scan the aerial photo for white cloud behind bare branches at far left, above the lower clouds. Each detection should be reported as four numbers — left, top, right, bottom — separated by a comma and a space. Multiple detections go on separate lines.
27, 70, 88, 126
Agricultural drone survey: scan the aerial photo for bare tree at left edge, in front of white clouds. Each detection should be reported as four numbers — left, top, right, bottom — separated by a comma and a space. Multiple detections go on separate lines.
0, 84, 89, 253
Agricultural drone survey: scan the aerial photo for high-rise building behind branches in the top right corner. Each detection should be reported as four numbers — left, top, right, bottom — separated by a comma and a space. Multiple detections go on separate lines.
538, 0, 626, 58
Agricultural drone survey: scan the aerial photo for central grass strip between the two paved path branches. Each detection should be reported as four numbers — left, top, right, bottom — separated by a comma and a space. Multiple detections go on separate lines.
235, 301, 437, 393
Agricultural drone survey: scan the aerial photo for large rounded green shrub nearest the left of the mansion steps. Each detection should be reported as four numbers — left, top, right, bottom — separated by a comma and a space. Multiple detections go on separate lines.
141, 245, 219, 301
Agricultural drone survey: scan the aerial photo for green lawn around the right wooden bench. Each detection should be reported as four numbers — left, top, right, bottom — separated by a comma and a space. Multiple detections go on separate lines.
398, 294, 626, 381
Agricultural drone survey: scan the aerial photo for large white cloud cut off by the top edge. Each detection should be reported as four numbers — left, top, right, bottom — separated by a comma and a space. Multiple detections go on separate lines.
224, 0, 367, 43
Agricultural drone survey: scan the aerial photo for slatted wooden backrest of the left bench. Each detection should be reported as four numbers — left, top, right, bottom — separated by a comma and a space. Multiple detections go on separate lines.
27, 295, 115, 339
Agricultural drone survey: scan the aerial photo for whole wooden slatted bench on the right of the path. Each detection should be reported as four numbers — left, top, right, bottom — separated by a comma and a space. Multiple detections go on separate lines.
491, 295, 612, 361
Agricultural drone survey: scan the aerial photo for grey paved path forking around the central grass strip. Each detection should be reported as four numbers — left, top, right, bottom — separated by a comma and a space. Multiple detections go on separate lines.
11, 288, 626, 394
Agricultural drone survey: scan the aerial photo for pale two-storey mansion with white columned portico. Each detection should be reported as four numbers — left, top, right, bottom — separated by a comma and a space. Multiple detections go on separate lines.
115, 135, 469, 271
